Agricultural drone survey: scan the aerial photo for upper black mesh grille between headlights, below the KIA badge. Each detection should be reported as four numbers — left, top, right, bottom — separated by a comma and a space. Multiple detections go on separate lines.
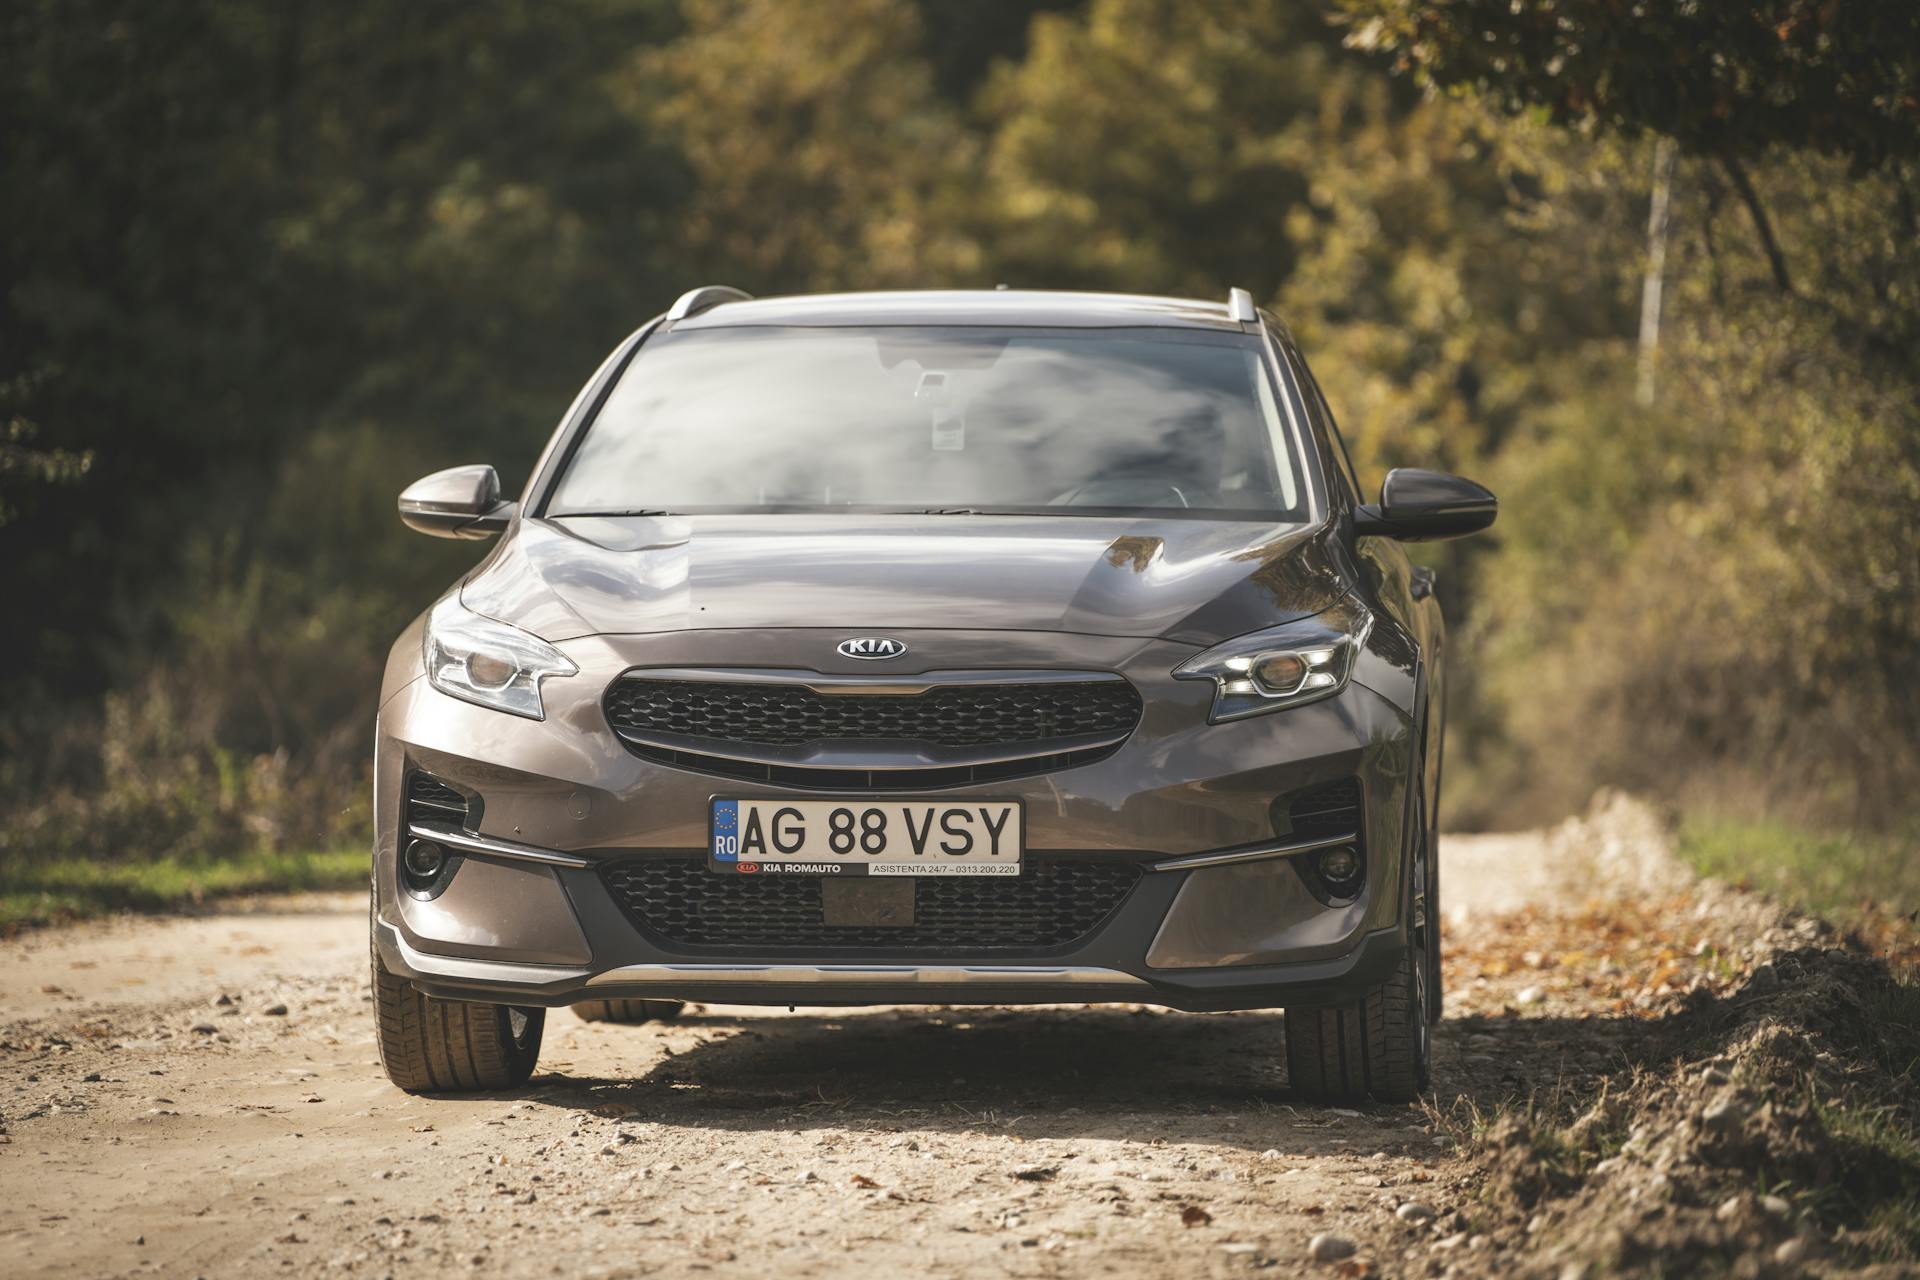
605, 674, 1140, 791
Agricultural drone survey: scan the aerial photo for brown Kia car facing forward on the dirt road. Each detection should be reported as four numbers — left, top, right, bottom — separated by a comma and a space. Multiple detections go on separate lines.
372, 288, 1494, 1100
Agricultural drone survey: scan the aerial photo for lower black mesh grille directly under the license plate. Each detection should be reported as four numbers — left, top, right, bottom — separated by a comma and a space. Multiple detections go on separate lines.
601, 854, 1140, 958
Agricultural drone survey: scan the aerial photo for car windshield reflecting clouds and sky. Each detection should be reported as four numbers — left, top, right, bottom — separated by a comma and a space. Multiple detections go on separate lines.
547, 326, 1308, 520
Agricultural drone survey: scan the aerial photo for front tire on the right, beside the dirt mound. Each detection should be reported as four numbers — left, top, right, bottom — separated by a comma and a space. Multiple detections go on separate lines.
1286, 790, 1434, 1102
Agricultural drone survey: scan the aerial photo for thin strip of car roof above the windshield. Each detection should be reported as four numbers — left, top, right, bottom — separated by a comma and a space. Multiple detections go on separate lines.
670, 290, 1242, 332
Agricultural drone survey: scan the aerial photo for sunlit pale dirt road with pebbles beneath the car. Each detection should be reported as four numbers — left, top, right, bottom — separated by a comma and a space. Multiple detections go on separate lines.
0, 805, 1881, 1278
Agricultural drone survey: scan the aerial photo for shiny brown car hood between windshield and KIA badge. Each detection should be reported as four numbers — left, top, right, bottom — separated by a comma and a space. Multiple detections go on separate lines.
461, 514, 1344, 645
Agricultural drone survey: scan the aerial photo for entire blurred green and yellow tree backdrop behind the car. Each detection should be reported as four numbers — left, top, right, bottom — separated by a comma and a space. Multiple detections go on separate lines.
0, 0, 1920, 856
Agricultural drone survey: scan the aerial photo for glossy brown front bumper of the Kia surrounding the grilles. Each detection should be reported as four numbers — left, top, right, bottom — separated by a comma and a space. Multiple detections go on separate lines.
374, 631, 1411, 1009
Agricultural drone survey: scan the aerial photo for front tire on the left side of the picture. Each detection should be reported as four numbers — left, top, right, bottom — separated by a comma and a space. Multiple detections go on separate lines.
372, 952, 547, 1094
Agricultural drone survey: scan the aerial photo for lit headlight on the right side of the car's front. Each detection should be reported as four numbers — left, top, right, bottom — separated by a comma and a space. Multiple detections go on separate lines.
1173, 597, 1373, 723
